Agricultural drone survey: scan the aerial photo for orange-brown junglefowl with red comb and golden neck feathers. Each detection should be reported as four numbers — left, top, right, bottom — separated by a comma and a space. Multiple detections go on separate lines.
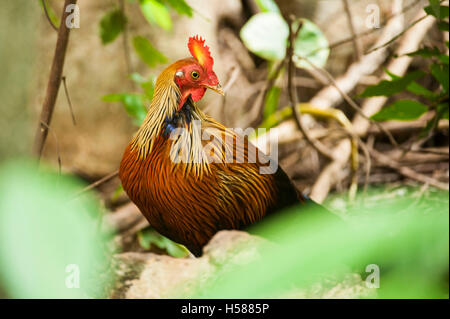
119, 36, 330, 256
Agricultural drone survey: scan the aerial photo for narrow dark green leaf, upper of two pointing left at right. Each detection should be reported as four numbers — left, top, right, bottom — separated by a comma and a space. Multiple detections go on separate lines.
360, 71, 425, 97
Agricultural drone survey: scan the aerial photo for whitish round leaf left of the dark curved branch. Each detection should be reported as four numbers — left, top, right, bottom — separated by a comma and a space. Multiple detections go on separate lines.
240, 12, 289, 61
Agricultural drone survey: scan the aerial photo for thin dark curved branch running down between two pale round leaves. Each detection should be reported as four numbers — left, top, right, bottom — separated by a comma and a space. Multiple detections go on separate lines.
286, 17, 334, 160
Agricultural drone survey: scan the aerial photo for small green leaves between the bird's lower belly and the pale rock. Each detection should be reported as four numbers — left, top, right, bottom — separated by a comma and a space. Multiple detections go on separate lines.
138, 227, 189, 258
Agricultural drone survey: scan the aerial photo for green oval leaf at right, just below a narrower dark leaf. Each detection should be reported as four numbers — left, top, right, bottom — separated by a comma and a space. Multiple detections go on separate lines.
371, 100, 428, 121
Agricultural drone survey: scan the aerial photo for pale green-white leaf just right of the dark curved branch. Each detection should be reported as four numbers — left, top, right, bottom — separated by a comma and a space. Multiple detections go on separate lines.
294, 19, 330, 69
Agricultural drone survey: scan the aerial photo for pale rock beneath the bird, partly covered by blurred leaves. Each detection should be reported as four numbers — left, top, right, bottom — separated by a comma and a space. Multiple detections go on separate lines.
110, 231, 374, 299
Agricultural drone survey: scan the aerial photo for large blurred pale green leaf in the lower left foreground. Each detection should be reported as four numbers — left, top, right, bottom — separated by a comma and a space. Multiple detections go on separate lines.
0, 161, 110, 298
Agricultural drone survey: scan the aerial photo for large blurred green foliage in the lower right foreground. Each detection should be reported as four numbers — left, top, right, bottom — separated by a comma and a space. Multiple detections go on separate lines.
195, 192, 449, 298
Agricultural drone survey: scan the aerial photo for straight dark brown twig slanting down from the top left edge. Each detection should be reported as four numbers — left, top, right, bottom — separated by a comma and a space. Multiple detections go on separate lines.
33, 0, 77, 159
